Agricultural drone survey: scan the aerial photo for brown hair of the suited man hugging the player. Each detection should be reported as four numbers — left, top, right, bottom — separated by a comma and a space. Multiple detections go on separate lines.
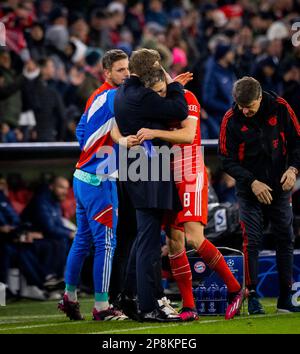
129, 48, 161, 77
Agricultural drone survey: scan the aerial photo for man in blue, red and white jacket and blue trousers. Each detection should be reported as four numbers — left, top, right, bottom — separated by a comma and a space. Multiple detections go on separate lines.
58, 49, 138, 320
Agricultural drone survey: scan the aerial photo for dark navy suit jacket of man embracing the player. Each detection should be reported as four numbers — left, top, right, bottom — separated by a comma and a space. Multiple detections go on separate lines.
114, 76, 188, 210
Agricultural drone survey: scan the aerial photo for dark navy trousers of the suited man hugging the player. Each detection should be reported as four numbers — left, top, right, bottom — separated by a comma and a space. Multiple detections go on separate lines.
125, 209, 163, 312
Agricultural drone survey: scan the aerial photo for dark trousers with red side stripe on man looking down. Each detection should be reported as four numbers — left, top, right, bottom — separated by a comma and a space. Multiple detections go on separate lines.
238, 192, 295, 296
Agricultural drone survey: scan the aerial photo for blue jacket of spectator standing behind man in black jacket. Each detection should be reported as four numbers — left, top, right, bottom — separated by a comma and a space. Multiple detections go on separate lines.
203, 59, 236, 118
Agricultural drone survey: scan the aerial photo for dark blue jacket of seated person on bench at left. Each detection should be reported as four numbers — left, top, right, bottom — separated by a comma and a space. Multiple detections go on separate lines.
22, 189, 71, 239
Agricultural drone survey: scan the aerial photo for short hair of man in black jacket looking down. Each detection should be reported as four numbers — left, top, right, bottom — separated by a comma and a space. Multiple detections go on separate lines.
232, 76, 262, 107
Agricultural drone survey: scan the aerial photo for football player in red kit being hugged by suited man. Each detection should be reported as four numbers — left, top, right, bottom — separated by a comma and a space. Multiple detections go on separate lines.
137, 68, 244, 321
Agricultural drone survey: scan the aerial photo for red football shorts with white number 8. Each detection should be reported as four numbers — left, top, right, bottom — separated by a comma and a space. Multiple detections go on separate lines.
171, 167, 208, 230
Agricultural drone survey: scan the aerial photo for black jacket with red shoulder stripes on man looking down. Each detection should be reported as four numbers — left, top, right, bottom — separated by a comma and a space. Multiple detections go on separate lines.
219, 92, 300, 193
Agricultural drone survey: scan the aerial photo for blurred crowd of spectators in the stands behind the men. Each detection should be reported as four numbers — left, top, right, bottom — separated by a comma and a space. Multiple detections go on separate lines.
0, 0, 300, 142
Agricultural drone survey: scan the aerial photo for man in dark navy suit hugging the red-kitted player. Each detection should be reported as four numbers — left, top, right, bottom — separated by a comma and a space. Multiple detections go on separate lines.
114, 49, 188, 322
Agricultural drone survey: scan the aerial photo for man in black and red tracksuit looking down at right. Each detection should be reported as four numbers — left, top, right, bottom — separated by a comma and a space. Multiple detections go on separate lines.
219, 77, 300, 314
